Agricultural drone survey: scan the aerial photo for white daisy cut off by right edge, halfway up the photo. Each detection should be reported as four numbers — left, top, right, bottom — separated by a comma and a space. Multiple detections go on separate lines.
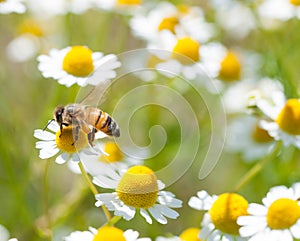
256, 91, 300, 148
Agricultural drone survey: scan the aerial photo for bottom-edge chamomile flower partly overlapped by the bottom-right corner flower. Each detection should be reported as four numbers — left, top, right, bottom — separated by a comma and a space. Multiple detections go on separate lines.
188, 191, 248, 241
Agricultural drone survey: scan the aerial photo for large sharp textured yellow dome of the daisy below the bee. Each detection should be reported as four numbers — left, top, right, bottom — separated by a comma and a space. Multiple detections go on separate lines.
116, 166, 158, 208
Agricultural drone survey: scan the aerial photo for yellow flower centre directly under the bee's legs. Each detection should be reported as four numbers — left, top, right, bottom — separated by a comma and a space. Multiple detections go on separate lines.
55, 126, 88, 153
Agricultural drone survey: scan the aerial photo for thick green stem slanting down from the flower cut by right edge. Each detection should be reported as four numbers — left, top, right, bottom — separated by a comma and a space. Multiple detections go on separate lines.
234, 141, 282, 192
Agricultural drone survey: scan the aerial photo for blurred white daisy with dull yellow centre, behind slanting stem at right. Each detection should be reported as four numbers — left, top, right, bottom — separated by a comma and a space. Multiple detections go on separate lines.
226, 116, 274, 162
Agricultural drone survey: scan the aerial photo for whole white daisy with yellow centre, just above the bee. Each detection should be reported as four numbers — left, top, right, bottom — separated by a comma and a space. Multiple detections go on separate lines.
38, 46, 121, 87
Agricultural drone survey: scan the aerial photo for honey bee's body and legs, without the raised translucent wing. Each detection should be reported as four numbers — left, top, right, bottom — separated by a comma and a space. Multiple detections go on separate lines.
53, 103, 120, 145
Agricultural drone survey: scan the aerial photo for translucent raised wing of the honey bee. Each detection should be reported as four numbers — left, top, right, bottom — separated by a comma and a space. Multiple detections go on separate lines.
76, 81, 110, 107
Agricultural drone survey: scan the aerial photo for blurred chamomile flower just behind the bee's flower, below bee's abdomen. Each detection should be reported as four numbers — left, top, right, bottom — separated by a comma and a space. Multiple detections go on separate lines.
81, 141, 143, 176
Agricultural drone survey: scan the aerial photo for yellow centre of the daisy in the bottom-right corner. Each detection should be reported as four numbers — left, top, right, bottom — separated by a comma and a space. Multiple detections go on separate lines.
267, 198, 300, 229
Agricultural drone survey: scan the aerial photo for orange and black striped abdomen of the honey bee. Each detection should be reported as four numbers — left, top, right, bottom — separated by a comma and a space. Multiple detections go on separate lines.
85, 107, 120, 137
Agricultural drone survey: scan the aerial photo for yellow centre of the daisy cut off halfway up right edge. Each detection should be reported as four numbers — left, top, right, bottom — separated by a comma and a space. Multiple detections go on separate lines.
276, 99, 300, 135
